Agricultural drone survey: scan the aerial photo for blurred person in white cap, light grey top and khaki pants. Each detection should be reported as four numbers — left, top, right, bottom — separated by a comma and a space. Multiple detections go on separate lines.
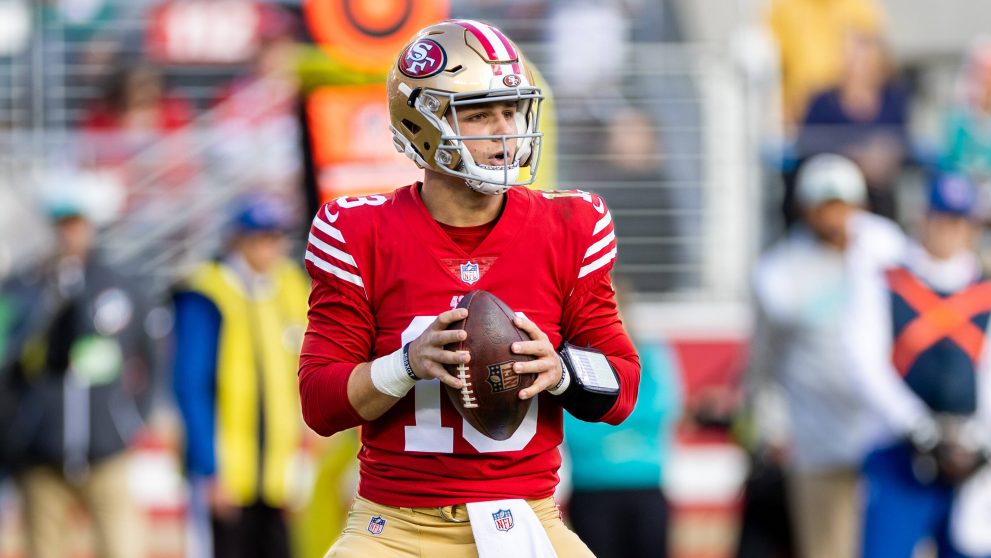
745, 154, 904, 558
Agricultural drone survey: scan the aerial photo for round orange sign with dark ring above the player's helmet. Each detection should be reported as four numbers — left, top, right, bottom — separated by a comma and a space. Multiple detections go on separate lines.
304, 0, 450, 72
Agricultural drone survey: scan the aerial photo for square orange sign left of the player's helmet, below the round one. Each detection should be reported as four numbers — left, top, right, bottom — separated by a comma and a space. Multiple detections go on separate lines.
306, 84, 423, 202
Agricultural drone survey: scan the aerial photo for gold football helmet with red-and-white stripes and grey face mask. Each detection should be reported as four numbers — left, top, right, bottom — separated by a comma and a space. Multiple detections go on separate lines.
388, 19, 543, 195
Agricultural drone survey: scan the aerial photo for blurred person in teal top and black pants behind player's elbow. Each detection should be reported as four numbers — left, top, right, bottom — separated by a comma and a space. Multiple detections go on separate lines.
564, 281, 682, 558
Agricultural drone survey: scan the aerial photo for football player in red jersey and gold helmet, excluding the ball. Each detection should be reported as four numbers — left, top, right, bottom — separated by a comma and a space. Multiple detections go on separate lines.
299, 20, 640, 558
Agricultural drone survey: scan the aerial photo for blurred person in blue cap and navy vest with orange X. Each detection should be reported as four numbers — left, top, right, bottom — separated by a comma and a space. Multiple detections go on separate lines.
849, 175, 991, 558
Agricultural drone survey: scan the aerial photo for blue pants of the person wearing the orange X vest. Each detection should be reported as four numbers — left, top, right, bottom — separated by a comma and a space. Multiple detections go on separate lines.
863, 443, 968, 558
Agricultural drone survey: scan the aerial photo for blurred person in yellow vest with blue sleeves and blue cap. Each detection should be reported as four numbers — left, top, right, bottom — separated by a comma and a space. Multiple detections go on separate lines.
174, 196, 309, 558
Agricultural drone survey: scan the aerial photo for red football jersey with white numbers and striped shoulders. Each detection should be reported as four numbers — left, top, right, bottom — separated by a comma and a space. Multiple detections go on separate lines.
300, 184, 640, 507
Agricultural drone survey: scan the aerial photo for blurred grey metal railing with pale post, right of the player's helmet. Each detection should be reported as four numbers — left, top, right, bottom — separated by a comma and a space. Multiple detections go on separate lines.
523, 43, 762, 303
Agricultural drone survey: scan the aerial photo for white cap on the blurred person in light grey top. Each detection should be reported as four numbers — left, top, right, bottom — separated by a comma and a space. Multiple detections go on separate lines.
795, 153, 867, 209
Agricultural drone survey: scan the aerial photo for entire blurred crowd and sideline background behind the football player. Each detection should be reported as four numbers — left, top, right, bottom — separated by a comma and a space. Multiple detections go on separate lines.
0, 0, 991, 558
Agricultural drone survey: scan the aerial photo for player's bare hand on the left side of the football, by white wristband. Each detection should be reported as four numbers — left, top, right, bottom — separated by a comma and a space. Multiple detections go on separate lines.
409, 308, 471, 389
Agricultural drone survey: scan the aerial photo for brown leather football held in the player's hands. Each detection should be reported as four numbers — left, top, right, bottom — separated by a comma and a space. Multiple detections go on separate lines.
444, 291, 536, 440
